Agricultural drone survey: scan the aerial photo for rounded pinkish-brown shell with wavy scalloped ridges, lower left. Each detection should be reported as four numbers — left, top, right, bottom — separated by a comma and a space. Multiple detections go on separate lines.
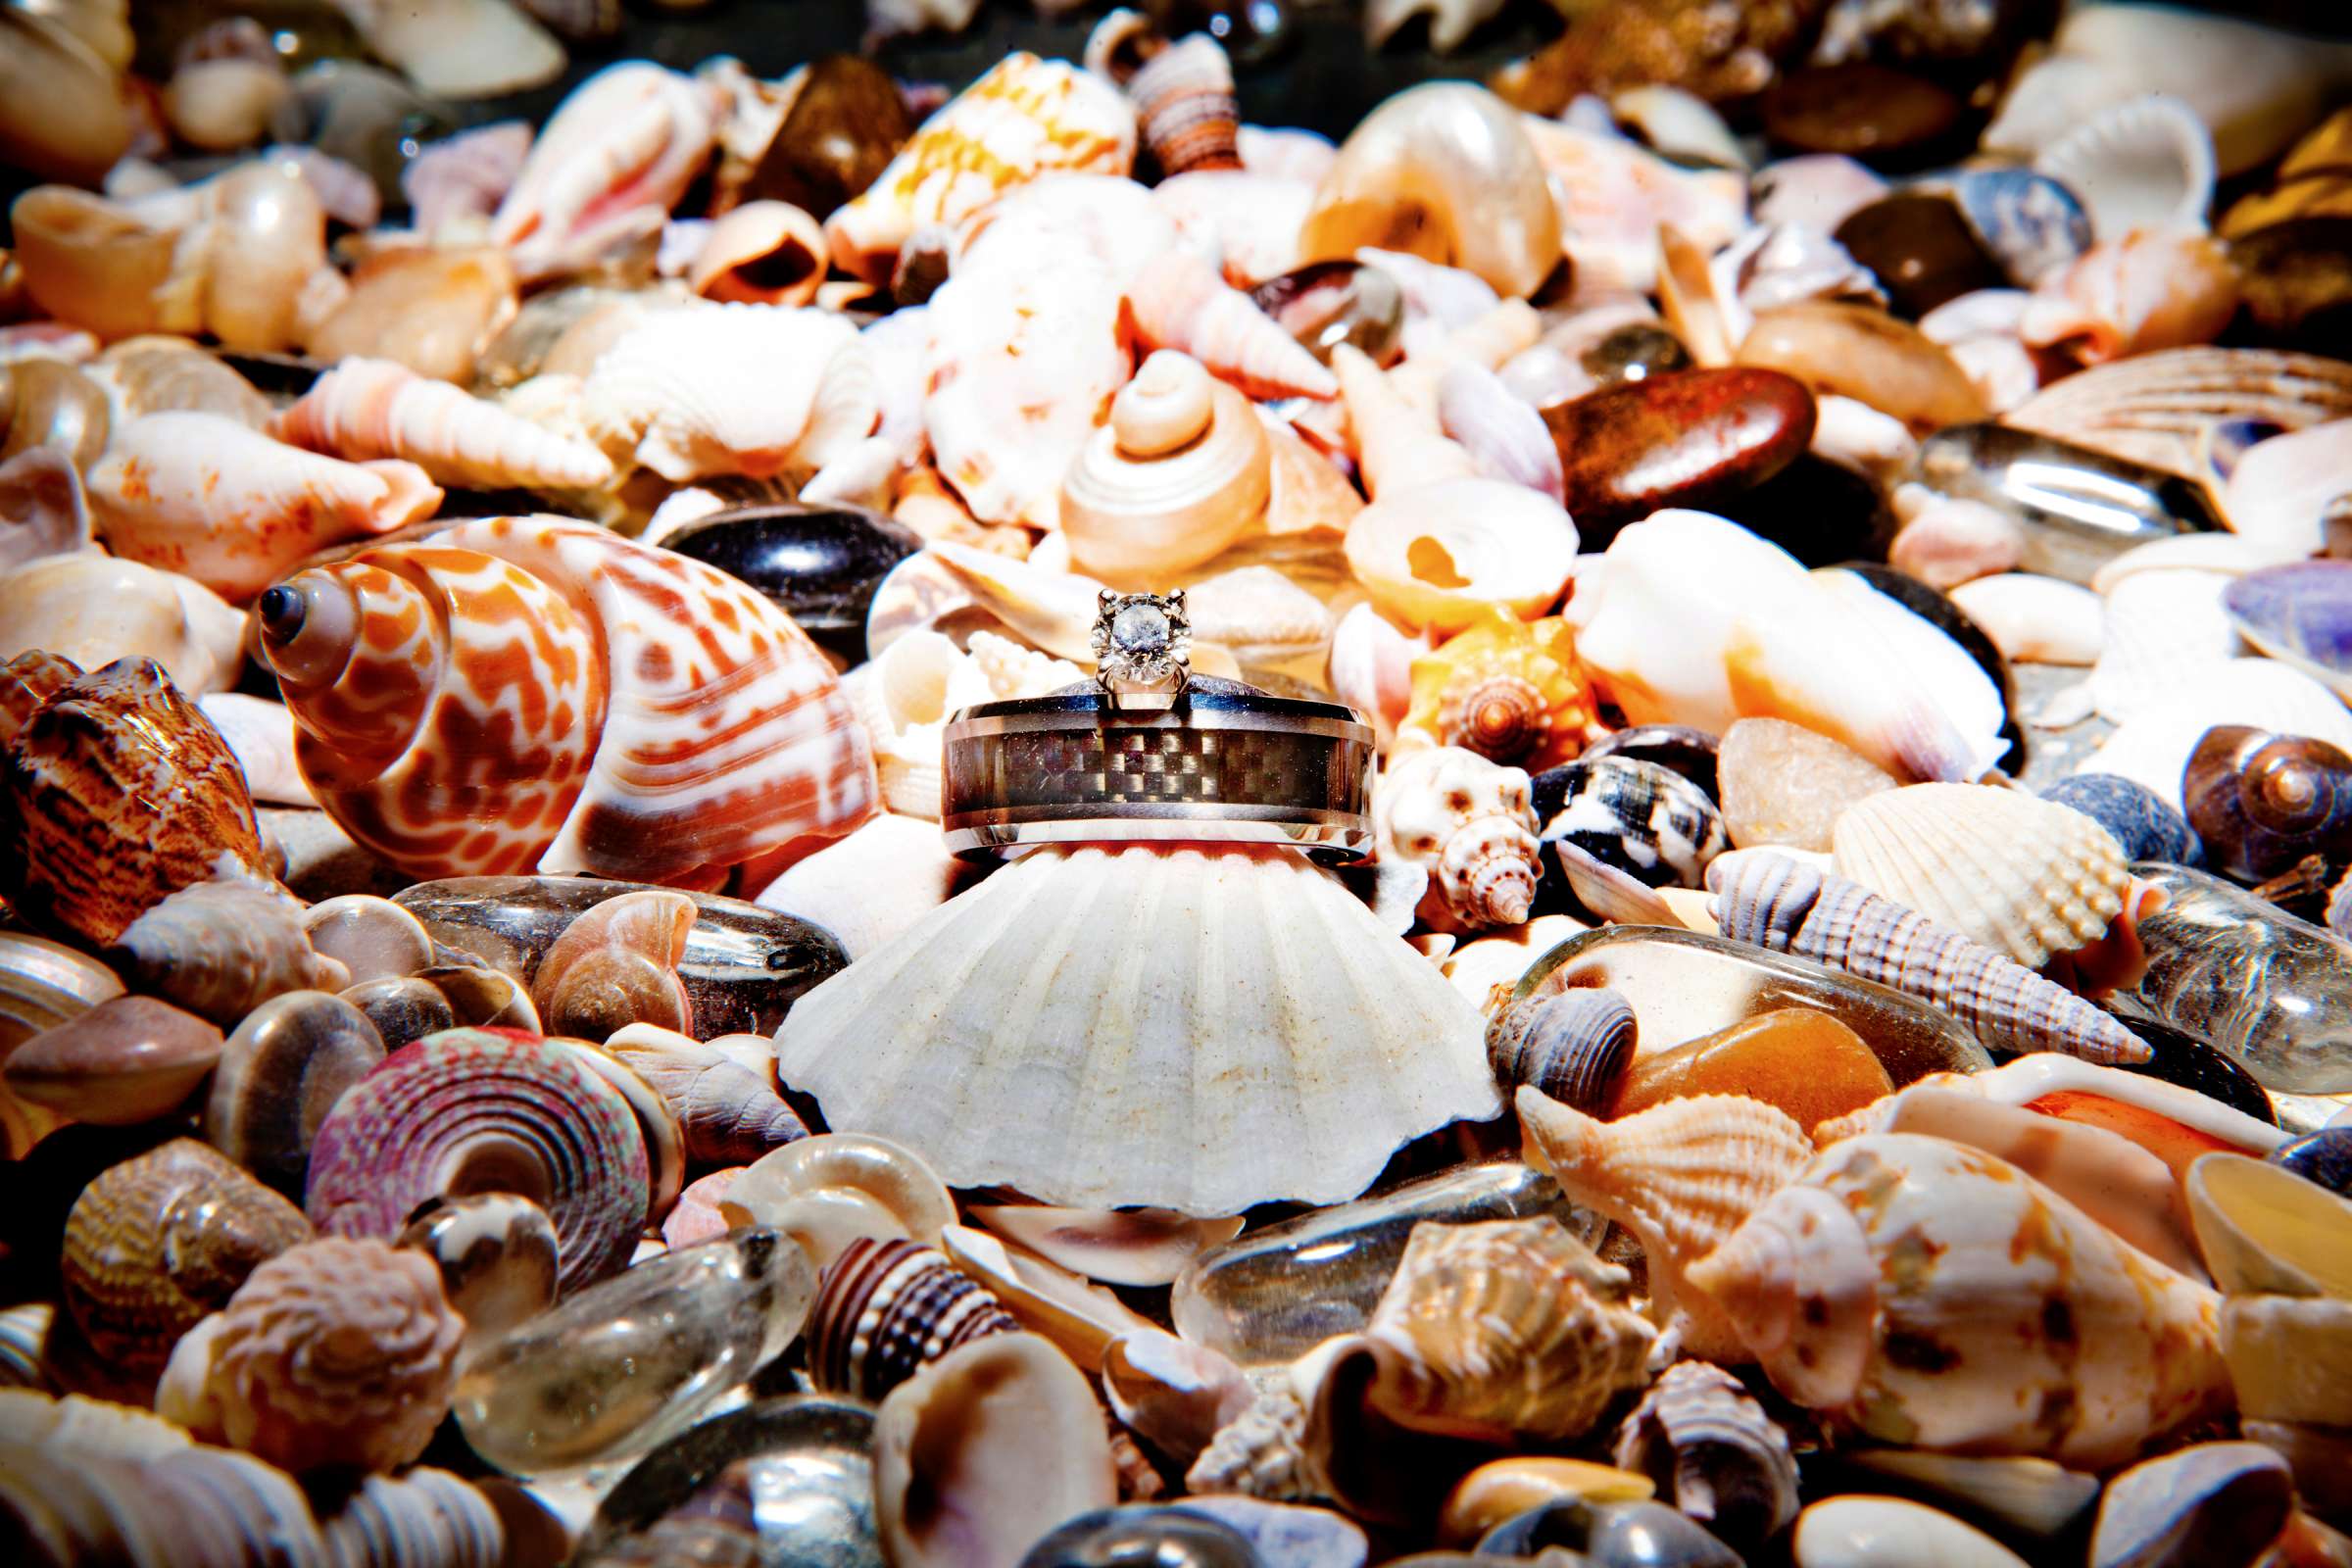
167, 1237, 466, 1472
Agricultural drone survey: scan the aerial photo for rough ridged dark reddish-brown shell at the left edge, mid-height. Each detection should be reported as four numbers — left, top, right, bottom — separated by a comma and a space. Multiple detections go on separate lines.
0, 659, 270, 948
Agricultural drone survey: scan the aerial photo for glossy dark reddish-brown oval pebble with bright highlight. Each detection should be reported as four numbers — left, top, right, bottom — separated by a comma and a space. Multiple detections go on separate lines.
1543, 369, 1813, 550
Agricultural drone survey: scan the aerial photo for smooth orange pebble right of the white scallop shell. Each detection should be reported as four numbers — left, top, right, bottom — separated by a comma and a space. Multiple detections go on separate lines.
1609, 1006, 1895, 1128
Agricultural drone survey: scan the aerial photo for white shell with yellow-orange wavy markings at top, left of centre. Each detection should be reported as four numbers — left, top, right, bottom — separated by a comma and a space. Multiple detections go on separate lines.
825, 54, 1136, 284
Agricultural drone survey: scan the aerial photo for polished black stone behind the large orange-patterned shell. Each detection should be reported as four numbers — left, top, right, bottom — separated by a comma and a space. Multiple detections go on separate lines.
661, 503, 922, 661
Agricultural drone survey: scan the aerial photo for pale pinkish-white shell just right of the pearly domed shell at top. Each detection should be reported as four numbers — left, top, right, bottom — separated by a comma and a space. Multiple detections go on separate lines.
1519, 116, 1759, 294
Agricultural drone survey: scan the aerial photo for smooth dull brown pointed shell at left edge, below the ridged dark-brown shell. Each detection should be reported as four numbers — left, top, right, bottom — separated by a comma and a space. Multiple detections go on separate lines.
7, 997, 221, 1126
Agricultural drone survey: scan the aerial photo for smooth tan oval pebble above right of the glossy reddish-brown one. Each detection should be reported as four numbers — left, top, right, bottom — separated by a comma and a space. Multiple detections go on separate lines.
1739, 299, 1987, 435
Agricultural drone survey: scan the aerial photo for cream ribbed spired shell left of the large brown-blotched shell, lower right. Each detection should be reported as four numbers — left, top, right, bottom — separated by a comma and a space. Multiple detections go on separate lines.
1517, 1089, 1813, 1361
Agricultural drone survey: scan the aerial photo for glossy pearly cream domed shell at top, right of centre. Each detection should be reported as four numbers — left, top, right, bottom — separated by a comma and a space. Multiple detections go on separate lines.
1298, 82, 1562, 299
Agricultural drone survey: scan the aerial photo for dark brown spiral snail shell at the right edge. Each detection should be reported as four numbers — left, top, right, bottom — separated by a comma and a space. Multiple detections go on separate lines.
2180, 724, 2352, 882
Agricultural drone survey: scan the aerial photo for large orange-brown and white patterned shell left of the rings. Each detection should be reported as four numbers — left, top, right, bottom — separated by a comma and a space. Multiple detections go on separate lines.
259, 517, 877, 882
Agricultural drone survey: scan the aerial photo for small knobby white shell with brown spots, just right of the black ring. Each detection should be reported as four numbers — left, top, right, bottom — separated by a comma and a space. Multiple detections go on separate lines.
1371, 745, 1543, 931
